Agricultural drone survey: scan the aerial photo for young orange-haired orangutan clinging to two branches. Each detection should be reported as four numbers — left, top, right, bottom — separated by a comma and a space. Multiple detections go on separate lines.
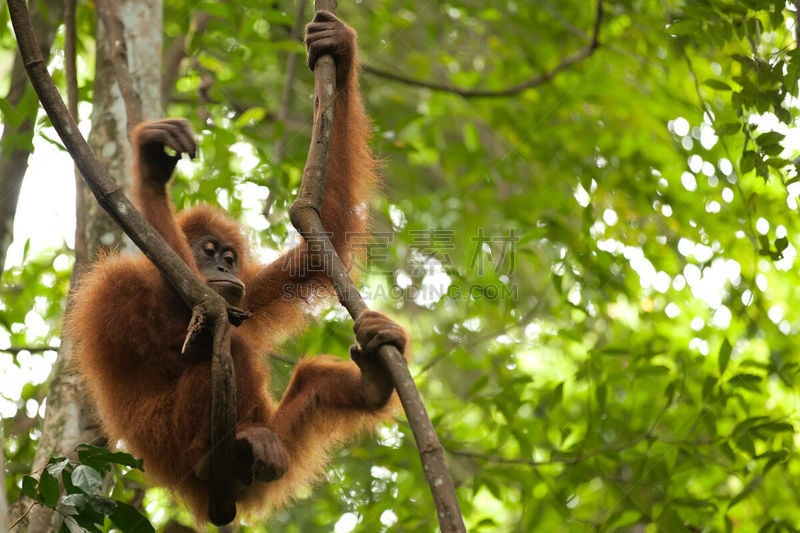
68, 12, 406, 517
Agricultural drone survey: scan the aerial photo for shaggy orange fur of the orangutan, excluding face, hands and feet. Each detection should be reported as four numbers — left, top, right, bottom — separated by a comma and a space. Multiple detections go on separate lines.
68, 15, 406, 517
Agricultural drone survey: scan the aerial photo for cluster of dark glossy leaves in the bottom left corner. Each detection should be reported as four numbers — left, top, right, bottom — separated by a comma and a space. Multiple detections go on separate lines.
22, 444, 155, 533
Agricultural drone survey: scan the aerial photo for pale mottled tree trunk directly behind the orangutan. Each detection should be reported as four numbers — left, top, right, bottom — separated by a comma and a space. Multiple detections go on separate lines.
28, 0, 163, 532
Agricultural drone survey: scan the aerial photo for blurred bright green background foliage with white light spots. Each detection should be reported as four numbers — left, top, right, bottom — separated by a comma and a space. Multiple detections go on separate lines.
0, 0, 800, 532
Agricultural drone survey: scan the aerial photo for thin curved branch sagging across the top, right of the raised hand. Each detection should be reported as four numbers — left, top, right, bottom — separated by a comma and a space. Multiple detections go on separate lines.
361, 0, 600, 98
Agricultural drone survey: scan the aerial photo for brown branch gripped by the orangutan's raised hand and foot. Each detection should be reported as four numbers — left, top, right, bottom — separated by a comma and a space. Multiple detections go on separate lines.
289, 0, 466, 533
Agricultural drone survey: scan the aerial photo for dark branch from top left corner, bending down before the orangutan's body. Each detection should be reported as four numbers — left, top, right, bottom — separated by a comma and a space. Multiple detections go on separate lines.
8, 0, 242, 524
